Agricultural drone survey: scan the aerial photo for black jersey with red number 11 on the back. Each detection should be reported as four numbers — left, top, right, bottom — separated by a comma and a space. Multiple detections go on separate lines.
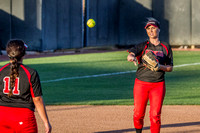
0, 63, 42, 111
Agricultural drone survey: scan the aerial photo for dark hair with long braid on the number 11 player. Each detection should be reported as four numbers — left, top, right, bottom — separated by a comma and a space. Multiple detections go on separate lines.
6, 39, 26, 97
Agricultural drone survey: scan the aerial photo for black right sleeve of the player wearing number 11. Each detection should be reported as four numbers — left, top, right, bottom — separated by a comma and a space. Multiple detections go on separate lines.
31, 71, 42, 97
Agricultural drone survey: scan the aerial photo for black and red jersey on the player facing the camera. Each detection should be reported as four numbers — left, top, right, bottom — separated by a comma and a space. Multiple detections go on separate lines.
128, 41, 173, 82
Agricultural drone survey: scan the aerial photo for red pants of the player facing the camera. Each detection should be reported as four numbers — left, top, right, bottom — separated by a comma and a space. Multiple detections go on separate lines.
133, 79, 165, 133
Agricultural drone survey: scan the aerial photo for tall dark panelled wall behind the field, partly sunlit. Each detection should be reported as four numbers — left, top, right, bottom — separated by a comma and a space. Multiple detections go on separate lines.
0, 0, 200, 51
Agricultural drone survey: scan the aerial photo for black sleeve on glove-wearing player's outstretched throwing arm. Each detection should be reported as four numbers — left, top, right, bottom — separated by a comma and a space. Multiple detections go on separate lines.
128, 42, 146, 56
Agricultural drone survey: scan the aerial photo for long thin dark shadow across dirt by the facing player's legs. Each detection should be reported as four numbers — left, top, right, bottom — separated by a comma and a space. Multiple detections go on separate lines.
95, 121, 200, 133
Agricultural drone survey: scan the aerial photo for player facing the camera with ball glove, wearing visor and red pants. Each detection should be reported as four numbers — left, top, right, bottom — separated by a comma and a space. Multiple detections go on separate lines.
127, 18, 173, 133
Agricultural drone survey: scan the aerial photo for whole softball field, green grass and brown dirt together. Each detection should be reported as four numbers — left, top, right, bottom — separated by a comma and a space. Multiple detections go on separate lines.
0, 49, 200, 133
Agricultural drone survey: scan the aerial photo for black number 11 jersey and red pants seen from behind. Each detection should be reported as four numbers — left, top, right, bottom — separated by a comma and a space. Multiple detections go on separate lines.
0, 64, 42, 132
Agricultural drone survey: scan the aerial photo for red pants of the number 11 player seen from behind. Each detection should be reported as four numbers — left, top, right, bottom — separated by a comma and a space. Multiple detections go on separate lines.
0, 106, 38, 133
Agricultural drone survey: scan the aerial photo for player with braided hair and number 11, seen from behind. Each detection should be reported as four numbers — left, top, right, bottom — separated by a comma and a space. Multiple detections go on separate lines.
0, 40, 51, 133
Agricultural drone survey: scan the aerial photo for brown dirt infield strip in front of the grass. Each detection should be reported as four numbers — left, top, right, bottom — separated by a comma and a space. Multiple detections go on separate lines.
35, 105, 200, 133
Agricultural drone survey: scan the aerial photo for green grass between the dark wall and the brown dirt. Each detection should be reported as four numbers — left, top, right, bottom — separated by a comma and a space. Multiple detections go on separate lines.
0, 51, 200, 105
